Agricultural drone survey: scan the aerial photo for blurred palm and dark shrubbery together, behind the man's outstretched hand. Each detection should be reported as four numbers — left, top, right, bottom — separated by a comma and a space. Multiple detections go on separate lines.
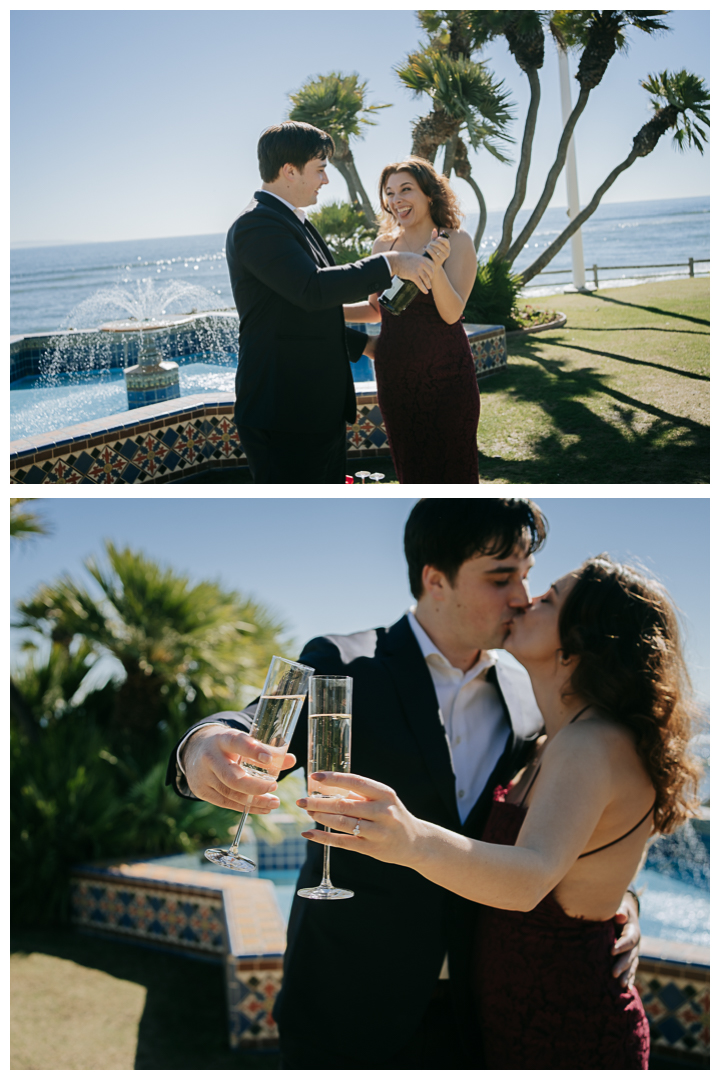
11, 544, 300, 924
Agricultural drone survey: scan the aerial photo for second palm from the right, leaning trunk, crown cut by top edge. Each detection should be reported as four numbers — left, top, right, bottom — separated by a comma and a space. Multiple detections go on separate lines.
502, 11, 668, 265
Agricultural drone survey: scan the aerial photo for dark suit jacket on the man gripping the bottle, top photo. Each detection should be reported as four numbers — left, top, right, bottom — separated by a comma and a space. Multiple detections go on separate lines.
226, 191, 391, 433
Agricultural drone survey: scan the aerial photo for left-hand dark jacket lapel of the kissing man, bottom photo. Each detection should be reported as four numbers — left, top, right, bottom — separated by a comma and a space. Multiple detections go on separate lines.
378, 617, 460, 826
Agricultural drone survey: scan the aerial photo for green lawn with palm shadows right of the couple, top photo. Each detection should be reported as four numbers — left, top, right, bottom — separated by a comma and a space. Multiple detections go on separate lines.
478, 278, 709, 484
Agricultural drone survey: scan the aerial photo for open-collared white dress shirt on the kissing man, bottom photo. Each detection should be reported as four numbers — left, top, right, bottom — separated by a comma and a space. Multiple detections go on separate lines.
408, 611, 511, 822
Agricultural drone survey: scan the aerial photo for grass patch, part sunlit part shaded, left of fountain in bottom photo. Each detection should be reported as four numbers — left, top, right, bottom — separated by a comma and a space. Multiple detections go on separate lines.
10, 930, 280, 1070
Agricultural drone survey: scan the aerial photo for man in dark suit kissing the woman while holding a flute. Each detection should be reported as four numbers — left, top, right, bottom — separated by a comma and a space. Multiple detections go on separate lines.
167, 499, 639, 1069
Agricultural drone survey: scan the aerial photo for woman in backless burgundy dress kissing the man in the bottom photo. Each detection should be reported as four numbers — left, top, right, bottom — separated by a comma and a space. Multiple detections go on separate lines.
305, 556, 698, 1069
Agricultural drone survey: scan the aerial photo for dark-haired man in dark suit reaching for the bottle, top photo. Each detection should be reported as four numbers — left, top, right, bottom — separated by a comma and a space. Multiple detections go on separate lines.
226, 121, 434, 484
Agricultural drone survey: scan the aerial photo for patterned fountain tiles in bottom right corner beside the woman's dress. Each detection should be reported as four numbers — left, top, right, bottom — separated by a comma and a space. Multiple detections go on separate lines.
635, 957, 710, 1066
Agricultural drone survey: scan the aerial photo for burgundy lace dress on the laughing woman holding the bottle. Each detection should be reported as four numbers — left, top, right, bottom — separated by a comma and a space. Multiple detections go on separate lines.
375, 293, 480, 484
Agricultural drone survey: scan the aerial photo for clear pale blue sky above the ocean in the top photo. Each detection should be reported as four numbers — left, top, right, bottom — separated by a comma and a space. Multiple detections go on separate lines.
11, 8, 710, 243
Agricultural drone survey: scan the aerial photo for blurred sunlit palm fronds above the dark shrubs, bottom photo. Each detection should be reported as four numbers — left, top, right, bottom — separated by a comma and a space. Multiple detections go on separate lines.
15, 542, 286, 748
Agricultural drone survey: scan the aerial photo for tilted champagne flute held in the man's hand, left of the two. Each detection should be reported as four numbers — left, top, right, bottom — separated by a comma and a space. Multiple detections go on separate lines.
205, 657, 315, 874
